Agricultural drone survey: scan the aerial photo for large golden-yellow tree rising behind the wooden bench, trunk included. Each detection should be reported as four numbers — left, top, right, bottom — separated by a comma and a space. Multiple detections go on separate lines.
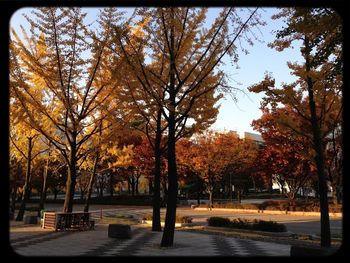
11, 7, 126, 212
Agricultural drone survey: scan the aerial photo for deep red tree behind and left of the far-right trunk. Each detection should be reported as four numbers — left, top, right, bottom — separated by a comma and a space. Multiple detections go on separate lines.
252, 107, 315, 201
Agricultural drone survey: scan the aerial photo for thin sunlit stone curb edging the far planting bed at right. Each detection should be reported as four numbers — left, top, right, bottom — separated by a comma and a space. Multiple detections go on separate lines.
193, 207, 343, 218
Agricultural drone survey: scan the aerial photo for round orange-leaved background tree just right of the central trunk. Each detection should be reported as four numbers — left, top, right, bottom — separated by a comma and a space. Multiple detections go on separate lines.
178, 132, 247, 208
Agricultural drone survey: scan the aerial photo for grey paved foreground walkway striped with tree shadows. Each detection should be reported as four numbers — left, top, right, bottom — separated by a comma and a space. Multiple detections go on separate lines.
10, 224, 290, 257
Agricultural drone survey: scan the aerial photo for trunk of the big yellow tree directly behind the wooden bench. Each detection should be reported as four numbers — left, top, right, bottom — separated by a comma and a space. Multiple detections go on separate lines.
63, 143, 77, 213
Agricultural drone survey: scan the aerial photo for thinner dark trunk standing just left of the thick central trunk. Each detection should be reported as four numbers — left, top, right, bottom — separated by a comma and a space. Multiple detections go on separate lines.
152, 110, 162, 231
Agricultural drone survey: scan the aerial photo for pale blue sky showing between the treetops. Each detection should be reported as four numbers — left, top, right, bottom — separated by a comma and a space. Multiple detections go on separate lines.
10, 8, 301, 136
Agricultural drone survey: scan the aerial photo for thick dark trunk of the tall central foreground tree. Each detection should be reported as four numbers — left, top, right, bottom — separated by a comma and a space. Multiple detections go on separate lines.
161, 8, 178, 247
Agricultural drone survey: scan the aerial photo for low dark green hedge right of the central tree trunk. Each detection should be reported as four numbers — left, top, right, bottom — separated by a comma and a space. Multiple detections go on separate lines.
207, 217, 287, 232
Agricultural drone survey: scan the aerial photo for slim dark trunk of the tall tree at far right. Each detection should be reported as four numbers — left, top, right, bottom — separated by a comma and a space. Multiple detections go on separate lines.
304, 37, 331, 247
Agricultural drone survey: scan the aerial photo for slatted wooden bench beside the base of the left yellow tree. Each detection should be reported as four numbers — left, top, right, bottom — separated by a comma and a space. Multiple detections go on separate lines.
42, 212, 95, 231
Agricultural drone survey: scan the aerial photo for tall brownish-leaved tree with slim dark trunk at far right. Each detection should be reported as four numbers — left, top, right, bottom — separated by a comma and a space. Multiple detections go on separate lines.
250, 8, 342, 247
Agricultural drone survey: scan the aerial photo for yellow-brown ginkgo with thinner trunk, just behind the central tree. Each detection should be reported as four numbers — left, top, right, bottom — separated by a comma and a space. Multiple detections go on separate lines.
109, 12, 227, 231
